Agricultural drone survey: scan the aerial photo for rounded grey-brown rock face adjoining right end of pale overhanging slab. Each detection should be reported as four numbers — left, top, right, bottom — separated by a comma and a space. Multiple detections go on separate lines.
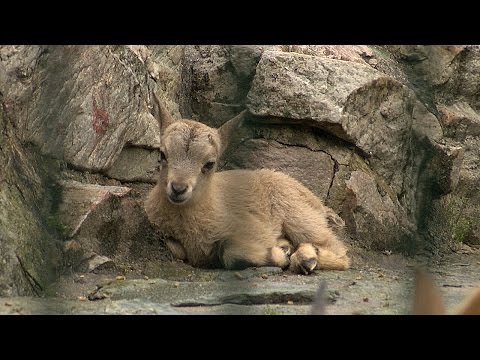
343, 78, 441, 206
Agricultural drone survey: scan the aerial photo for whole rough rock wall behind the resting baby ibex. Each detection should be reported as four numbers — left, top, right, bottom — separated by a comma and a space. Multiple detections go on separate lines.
4, 45, 480, 304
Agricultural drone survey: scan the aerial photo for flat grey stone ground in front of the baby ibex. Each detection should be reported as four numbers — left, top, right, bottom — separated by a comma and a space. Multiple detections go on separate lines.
0, 251, 479, 315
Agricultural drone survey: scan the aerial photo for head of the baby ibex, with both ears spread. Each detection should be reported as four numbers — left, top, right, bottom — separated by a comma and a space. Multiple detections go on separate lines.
152, 94, 245, 205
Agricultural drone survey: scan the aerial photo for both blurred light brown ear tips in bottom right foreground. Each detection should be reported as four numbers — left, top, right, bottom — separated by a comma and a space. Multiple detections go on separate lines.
413, 270, 480, 315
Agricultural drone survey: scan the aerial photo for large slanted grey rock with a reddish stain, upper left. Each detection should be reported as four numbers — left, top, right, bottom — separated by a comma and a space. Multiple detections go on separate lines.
25, 46, 158, 171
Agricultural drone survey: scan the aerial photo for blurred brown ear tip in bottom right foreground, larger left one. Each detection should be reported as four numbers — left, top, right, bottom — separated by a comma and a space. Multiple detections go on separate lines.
413, 269, 446, 315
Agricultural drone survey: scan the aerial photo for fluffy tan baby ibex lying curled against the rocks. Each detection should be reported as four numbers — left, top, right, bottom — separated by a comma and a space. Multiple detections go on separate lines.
145, 94, 350, 274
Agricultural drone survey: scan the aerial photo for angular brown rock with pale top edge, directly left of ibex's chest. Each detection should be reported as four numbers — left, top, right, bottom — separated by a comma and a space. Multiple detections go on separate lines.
59, 180, 166, 272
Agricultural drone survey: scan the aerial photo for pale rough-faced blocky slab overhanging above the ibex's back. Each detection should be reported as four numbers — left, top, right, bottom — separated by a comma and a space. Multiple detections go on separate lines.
248, 51, 383, 140
